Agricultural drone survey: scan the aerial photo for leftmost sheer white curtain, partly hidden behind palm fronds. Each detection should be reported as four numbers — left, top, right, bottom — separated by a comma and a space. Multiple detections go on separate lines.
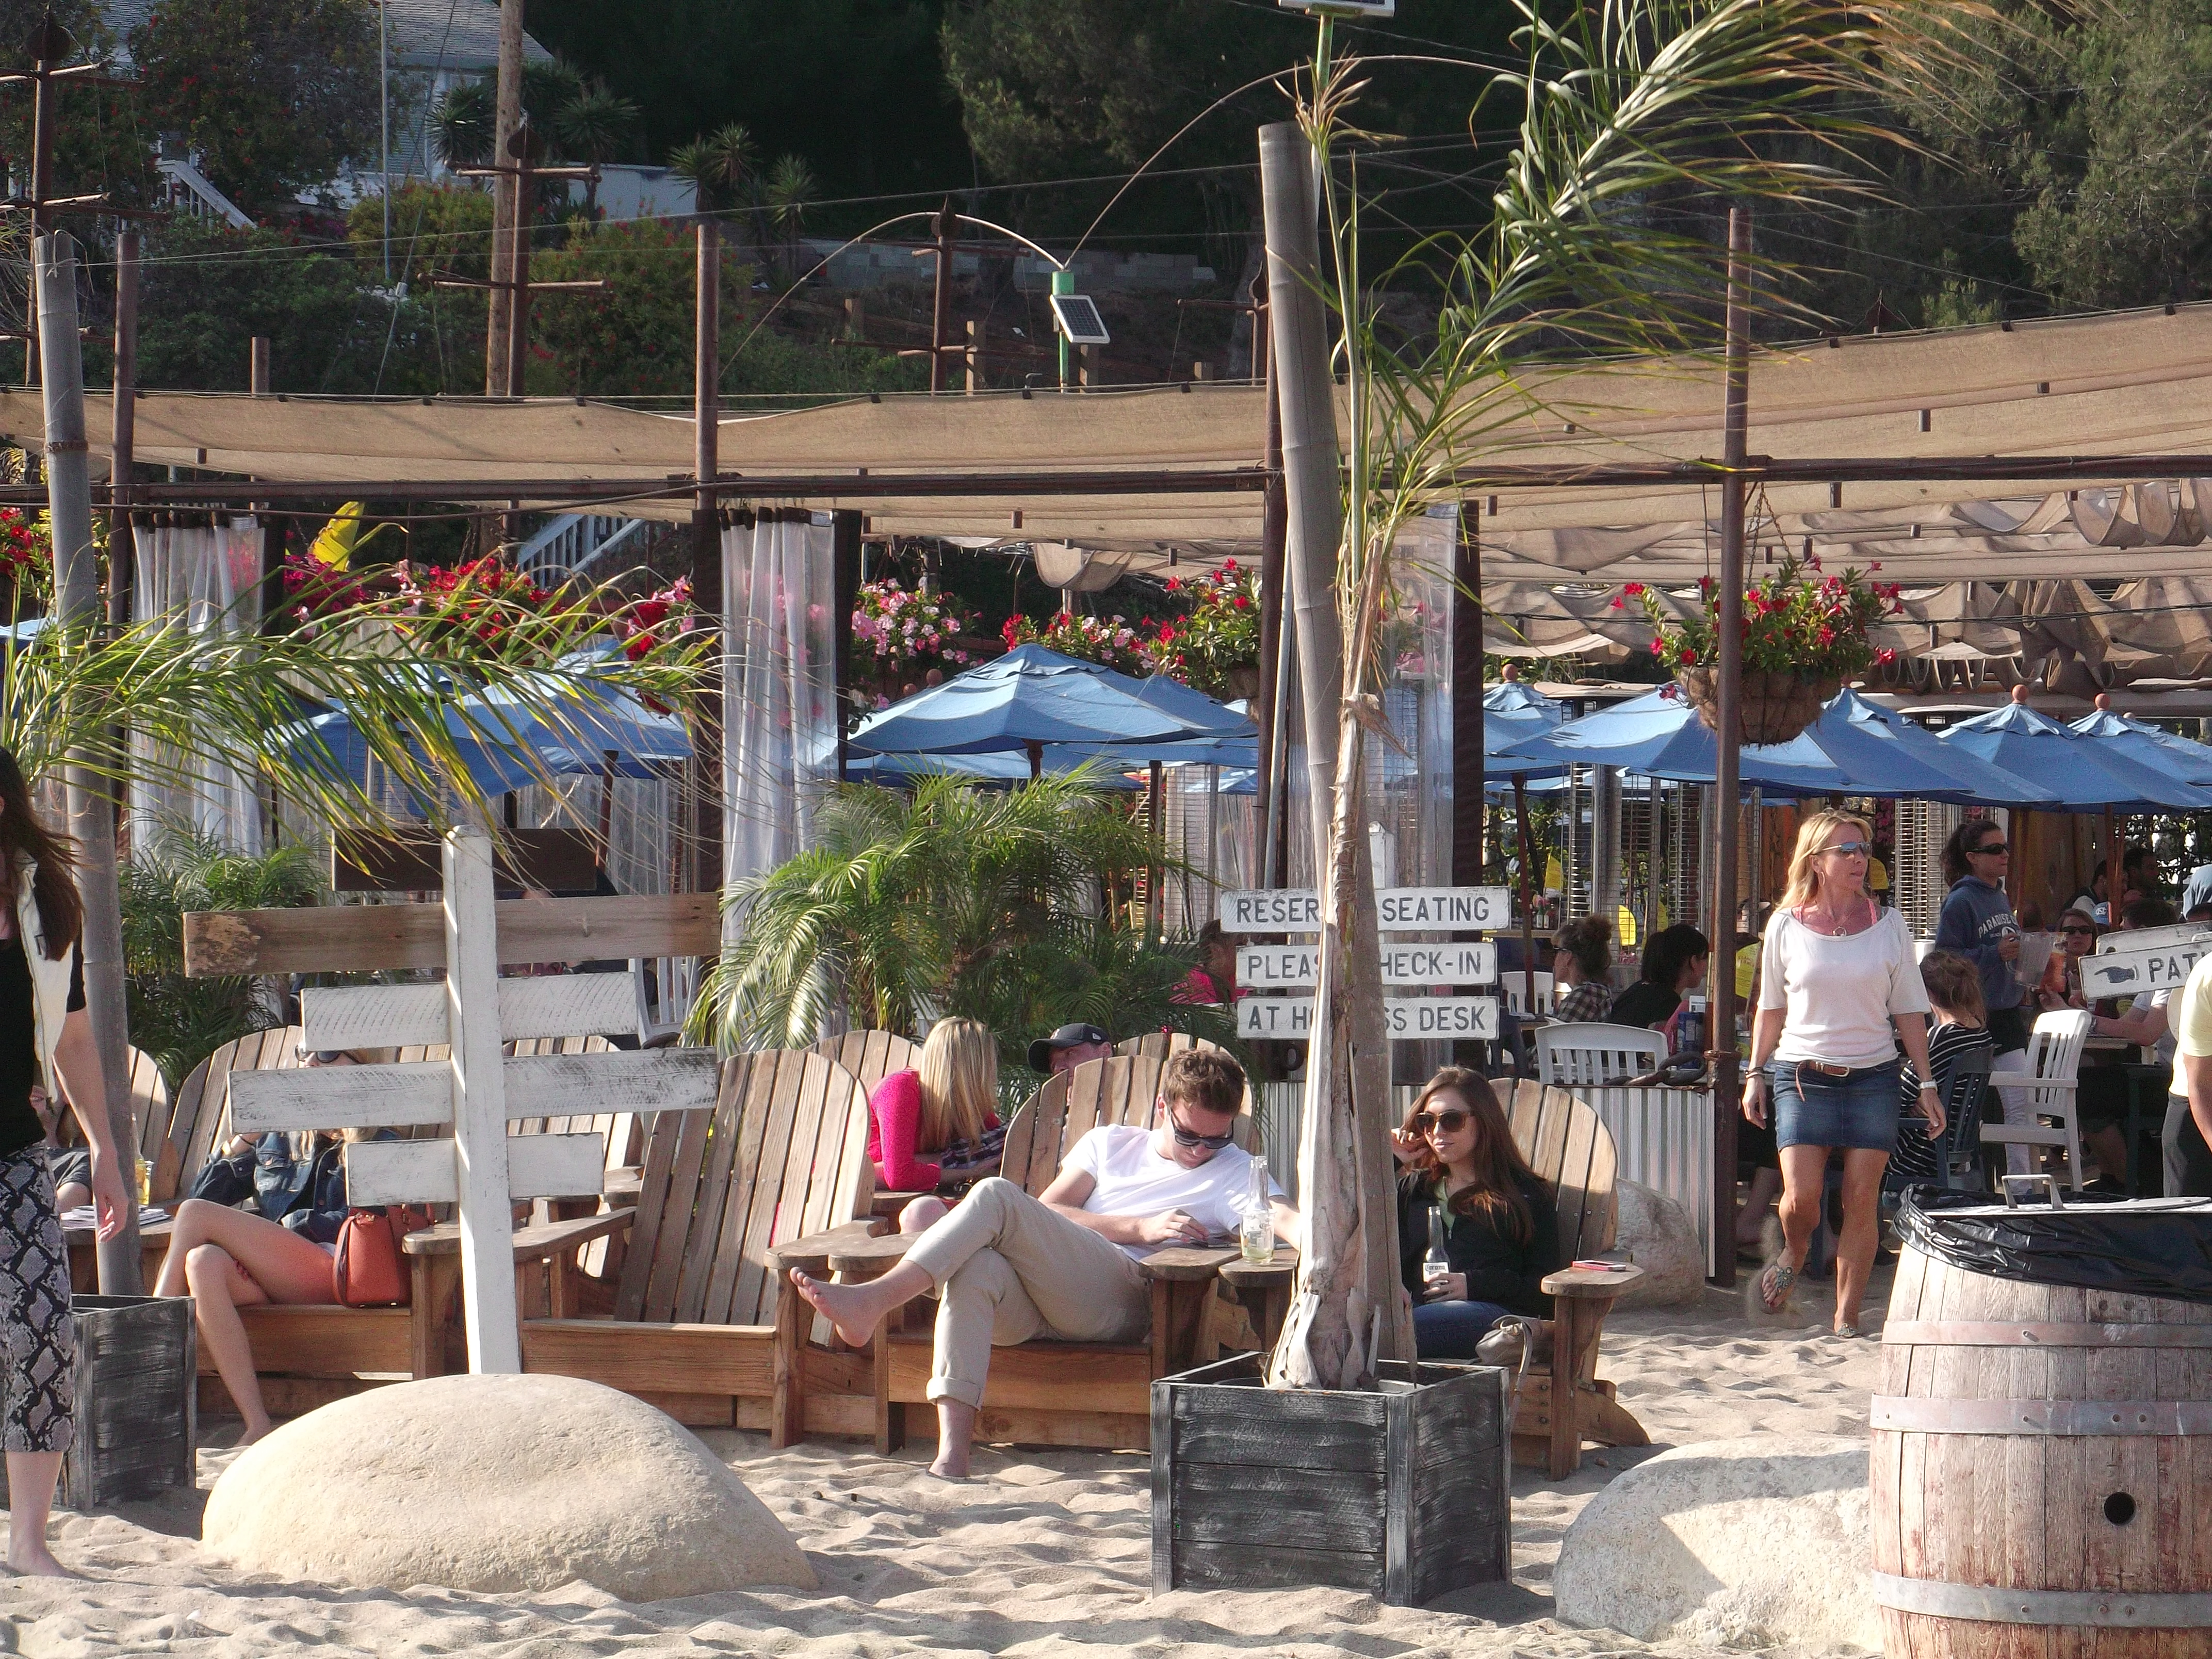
131, 517, 261, 854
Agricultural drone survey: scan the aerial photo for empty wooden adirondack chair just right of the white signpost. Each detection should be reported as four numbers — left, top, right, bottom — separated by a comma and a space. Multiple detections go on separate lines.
522, 1049, 874, 1446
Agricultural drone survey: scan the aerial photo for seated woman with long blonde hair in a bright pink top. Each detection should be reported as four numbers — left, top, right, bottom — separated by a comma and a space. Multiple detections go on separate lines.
867, 1015, 1006, 1232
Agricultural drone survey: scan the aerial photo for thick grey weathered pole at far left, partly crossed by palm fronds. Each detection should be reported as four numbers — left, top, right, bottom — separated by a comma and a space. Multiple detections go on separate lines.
37, 235, 141, 1296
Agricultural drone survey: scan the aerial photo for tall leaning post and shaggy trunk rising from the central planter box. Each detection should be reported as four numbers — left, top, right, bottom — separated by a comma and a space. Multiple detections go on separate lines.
1261, 122, 1411, 1389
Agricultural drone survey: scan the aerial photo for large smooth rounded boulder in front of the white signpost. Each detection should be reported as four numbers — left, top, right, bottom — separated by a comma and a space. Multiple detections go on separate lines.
201, 1376, 814, 1602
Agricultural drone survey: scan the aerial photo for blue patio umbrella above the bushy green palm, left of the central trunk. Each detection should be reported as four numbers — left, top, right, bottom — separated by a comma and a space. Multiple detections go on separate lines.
847, 646, 1257, 761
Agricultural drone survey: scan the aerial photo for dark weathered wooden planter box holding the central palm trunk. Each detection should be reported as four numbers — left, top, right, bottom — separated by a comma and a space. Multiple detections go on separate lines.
1152, 1354, 1513, 1606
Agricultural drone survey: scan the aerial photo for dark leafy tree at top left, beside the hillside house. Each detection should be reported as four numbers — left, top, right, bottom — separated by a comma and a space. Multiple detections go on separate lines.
131, 0, 385, 217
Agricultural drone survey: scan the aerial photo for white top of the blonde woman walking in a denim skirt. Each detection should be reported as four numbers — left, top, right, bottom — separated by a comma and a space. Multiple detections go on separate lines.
1759, 909, 1931, 1066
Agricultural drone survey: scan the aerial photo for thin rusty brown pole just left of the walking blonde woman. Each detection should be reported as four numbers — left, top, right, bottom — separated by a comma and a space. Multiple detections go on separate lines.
1712, 208, 1752, 1285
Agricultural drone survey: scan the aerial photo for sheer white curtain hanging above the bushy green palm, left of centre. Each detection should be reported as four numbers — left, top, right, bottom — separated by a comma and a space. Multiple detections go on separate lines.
721, 509, 836, 911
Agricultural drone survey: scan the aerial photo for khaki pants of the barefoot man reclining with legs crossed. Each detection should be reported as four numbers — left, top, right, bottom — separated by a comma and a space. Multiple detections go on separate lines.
907, 1177, 1152, 1407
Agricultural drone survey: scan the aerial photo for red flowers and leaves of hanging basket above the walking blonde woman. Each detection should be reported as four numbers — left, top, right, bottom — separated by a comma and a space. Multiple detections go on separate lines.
1615, 560, 1900, 681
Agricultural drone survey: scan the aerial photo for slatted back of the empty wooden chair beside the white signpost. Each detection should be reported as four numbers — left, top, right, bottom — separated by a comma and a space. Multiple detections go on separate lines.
615, 1049, 876, 1325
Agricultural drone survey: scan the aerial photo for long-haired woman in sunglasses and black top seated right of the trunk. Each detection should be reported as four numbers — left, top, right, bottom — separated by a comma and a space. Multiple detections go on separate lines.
1391, 1066, 1566, 1360
